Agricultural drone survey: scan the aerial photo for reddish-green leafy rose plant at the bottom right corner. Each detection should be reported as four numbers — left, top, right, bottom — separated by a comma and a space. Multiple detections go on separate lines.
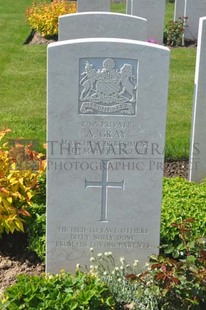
143, 219, 206, 310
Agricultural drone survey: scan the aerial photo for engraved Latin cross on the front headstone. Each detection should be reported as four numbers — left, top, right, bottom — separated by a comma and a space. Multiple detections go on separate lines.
85, 160, 124, 222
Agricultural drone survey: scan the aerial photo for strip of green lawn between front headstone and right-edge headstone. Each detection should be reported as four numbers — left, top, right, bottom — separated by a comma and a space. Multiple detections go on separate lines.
166, 48, 196, 158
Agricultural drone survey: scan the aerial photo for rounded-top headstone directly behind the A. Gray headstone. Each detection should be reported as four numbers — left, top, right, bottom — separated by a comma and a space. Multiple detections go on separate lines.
58, 12, 147, 41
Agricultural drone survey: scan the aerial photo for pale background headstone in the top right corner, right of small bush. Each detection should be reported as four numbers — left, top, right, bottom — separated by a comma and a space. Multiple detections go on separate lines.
184, 0, 206, 40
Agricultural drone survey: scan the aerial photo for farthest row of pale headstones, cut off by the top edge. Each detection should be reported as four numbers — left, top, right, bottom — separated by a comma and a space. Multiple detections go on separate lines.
78, 0, 206, 43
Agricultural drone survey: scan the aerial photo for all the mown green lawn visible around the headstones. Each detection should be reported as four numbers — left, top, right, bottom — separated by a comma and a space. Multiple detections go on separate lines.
0, 0, 196, 157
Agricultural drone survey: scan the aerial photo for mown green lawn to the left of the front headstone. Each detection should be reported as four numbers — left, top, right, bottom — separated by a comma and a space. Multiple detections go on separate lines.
0, 0, 46, 148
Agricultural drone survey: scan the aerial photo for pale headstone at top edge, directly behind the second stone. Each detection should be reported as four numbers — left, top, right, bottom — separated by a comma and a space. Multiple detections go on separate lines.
77, 0, 110, 12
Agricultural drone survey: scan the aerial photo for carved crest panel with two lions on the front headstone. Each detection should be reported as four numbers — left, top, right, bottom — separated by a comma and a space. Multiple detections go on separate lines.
78, 58, 137, 116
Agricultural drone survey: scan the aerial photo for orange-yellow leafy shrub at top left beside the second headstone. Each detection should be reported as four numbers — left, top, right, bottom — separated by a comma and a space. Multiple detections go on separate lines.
26, 0, 76, 37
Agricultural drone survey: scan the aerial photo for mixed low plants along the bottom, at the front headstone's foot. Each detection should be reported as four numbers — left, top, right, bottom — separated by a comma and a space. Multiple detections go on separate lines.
0, 242, 206, 310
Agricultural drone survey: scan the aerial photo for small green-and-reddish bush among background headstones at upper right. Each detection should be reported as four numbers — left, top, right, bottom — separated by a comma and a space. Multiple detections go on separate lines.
163, 17, 187, 46
